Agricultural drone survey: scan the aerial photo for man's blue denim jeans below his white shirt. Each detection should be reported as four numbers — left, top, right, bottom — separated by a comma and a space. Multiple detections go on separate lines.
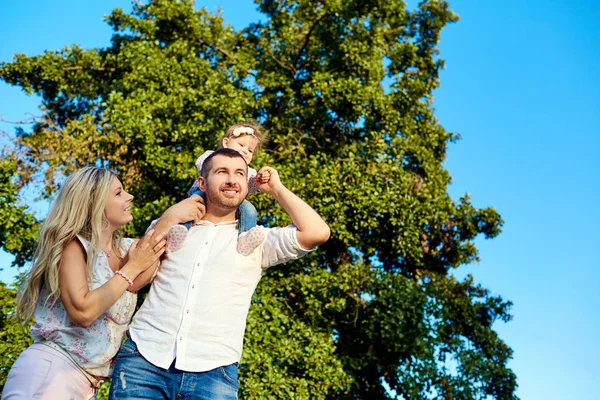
108, 339, 238, 400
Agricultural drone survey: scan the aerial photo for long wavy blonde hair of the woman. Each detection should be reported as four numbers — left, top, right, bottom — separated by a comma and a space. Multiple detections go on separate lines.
16, 167, 124, 324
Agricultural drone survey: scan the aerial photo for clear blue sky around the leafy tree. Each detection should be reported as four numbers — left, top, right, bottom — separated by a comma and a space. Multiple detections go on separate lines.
0, 0, 600, 400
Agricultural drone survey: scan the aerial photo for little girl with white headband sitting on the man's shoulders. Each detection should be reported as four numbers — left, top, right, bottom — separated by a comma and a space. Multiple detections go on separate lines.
167, 123, 270, 253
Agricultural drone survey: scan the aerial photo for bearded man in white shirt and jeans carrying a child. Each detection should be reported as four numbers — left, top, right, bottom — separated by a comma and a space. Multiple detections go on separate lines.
110, 149, 330, 400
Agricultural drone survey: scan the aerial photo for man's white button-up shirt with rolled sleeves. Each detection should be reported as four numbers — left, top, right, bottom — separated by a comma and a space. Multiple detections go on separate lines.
129, 221, 310, 372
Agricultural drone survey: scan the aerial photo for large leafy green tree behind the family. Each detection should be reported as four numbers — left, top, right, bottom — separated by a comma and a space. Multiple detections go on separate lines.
0, 0, 516, 399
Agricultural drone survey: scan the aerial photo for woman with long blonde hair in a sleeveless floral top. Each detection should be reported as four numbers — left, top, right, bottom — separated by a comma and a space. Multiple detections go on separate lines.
2, 167, 197, 400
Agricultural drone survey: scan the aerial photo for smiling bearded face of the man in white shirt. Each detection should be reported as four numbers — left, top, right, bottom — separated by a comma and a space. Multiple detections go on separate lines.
198, 153, 248, 213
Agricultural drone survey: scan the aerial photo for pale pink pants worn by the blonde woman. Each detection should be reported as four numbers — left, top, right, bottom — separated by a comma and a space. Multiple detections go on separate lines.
2, 343, 96, 400
